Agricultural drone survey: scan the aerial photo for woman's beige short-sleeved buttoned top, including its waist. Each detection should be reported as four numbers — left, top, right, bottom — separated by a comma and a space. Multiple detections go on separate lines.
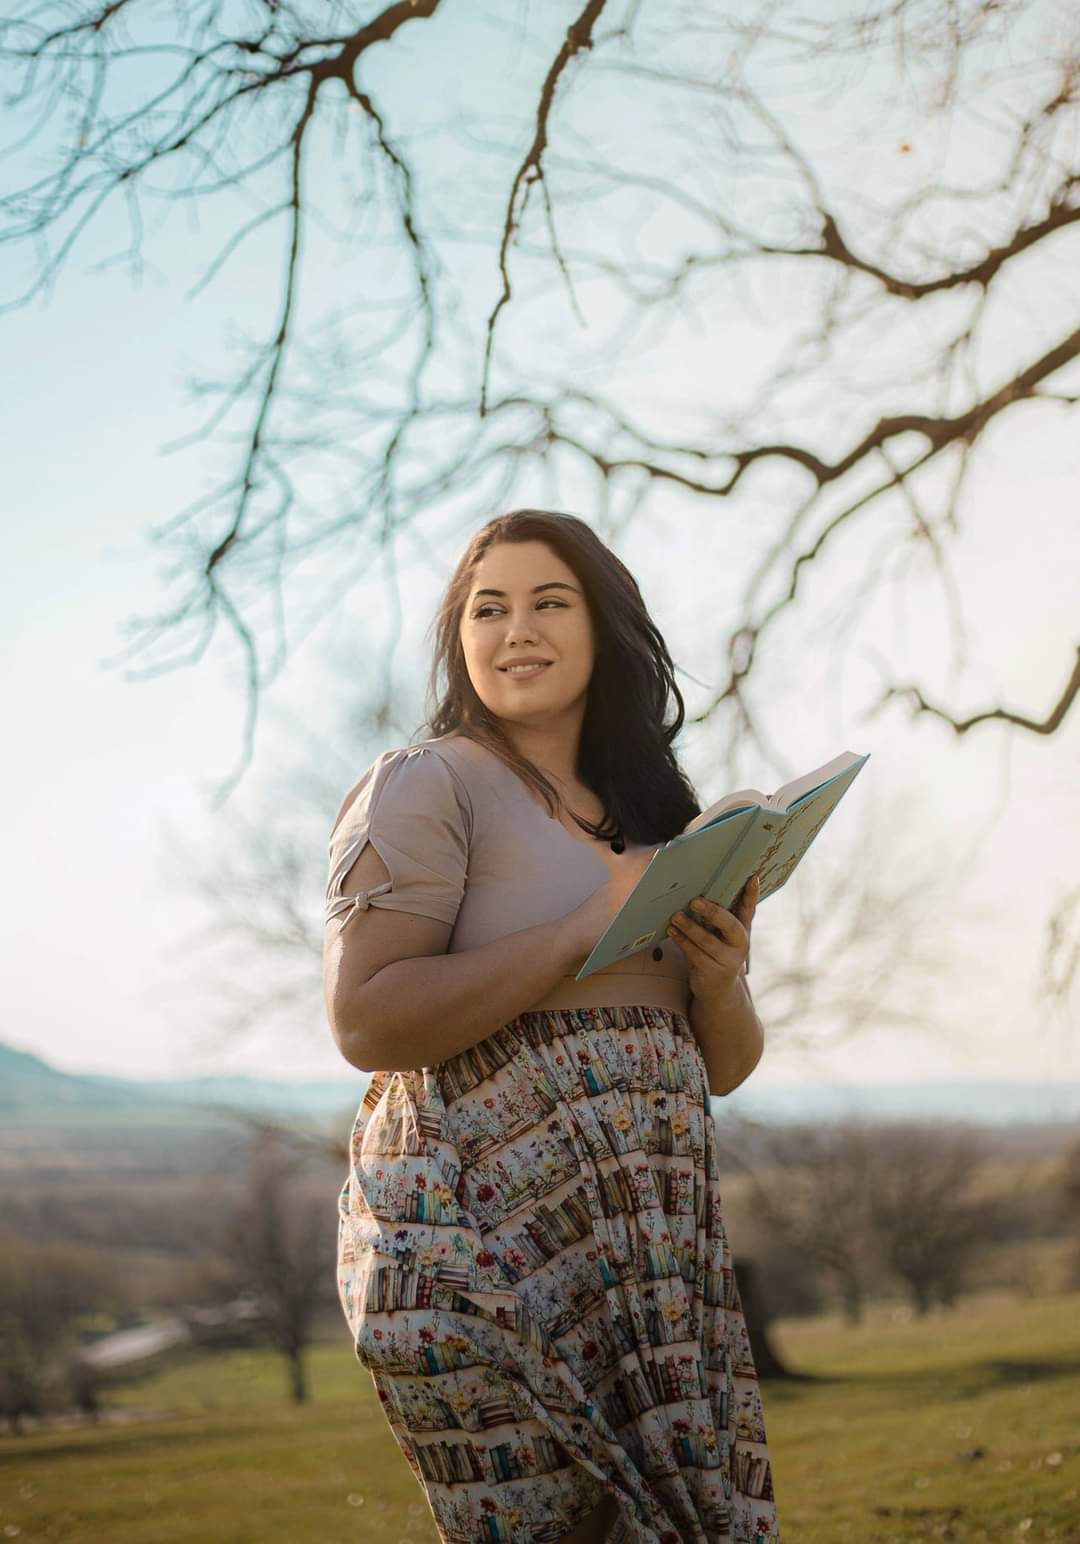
326, 735, 689, 1013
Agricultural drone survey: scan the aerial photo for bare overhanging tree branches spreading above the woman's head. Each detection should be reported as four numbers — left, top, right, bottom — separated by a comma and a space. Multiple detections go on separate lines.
0, 0, 1080, 801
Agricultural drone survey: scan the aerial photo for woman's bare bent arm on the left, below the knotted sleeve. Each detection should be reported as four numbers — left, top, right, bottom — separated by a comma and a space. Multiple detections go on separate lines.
323, 845, 652, 1072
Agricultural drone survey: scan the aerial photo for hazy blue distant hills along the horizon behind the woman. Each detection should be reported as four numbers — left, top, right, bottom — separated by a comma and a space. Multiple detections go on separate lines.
0, 1044, 1080, 1185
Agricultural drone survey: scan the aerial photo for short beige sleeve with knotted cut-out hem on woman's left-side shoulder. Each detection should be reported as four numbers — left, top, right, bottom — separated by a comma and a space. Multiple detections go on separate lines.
326, 746, 473, 931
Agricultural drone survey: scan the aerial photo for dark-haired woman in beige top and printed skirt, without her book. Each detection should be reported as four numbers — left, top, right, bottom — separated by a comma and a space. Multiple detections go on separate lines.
324, 510, 780, 1544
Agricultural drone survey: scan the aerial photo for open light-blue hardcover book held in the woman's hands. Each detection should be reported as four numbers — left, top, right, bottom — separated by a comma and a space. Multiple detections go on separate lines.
575, 750, 868, 980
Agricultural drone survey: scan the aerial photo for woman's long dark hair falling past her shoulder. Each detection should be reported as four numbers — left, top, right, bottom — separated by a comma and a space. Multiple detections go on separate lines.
423, 510, 701, 845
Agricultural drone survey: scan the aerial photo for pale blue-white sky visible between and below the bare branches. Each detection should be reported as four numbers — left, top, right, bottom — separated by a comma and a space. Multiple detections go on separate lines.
0, 6, 1080, 1105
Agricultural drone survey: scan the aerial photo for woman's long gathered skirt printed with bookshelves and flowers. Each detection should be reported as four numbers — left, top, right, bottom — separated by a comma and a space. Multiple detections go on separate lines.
338, 1007, 780, 1544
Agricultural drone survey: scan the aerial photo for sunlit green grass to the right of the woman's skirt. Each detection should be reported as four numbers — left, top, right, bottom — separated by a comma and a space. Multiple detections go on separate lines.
763, 1292, 1080, 1544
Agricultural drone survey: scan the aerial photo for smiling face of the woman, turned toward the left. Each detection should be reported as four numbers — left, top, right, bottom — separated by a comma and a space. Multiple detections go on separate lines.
460, 540, 595, 724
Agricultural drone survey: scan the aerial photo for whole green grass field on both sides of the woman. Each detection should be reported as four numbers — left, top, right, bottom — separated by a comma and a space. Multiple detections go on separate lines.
0, 1292, 1080, 1544
